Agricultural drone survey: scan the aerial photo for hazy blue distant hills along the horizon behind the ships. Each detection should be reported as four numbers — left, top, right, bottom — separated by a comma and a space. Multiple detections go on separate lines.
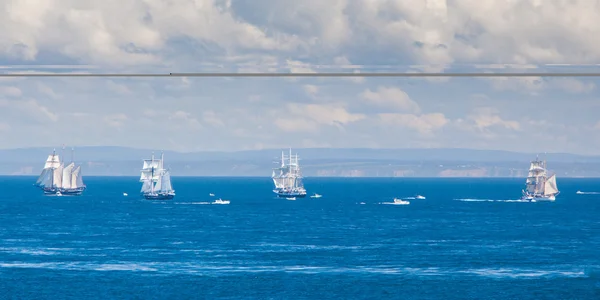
0, 147, 600, 177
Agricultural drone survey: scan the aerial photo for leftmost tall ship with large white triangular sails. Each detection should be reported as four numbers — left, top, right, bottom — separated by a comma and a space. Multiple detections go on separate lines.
35, 150, 86, 196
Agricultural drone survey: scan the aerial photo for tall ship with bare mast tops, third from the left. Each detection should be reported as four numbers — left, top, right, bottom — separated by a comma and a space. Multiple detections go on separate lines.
271, 149, 306, 198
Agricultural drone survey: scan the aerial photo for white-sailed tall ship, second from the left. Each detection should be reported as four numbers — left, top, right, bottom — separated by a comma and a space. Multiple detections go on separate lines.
140, 154, 175, 200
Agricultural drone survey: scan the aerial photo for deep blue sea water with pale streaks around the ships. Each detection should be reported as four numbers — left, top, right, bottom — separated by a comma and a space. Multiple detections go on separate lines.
0, 177, 600, 299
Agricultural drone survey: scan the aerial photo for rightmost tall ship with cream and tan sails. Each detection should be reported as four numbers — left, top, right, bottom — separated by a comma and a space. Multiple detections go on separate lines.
521, 157, 560, 202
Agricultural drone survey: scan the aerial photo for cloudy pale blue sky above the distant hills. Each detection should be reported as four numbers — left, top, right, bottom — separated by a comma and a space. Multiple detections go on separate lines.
0, 0, 600, 155
